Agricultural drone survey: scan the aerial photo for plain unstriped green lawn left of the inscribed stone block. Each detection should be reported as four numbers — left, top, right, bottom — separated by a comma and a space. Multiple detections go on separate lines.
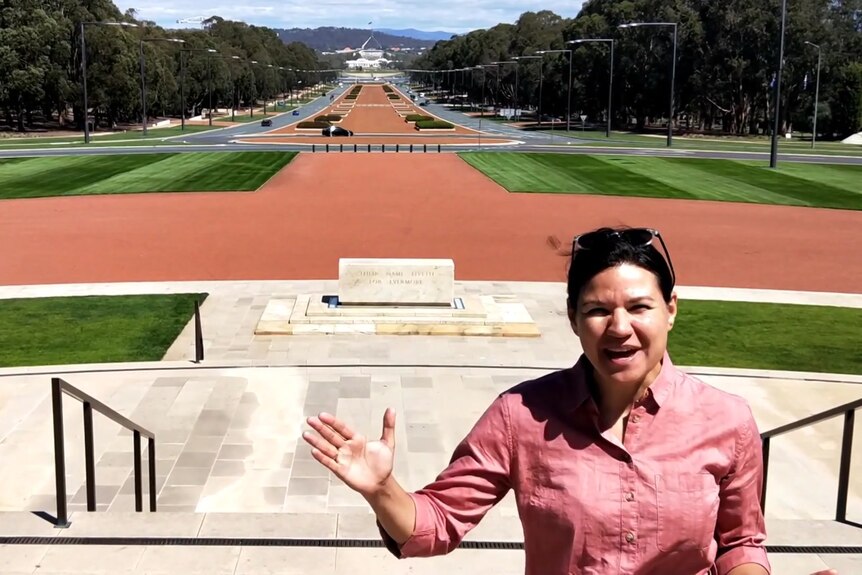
0, 294, 207, 367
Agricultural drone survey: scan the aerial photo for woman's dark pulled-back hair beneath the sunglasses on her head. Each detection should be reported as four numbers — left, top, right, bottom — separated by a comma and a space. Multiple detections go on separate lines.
548, 227, 674, 309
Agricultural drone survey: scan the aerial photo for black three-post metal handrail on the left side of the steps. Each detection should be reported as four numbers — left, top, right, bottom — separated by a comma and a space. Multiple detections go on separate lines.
51, 377, 156, 527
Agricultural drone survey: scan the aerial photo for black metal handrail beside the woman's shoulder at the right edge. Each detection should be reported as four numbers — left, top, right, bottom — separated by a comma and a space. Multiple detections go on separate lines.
760, 398, 862, 522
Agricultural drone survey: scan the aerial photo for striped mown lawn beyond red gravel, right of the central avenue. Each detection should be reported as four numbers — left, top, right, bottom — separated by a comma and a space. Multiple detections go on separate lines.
460, 152, 862, 210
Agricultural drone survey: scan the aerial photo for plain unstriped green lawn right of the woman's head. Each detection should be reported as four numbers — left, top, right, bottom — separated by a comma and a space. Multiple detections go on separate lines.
668, 300, 862, 375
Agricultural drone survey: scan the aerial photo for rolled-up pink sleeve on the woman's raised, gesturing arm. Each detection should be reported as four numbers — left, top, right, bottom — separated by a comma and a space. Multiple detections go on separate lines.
378, 395, 512, 558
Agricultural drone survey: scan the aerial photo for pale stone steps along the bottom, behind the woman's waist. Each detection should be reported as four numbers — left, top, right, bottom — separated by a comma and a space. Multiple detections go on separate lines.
0, 512, 862, 575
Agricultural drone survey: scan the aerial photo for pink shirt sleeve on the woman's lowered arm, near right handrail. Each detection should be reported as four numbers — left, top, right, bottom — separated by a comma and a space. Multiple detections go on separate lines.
715, 406, 771, 575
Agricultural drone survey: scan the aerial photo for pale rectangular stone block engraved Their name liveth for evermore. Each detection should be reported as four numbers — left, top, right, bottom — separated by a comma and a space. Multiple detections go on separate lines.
338, 258, 455, 305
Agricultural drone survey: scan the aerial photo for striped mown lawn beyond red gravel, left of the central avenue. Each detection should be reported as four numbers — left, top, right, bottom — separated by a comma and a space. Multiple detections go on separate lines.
0, 152, 296, 199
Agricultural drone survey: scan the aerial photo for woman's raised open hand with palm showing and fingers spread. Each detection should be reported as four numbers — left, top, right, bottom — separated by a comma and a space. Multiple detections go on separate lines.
302, 409, 395, 496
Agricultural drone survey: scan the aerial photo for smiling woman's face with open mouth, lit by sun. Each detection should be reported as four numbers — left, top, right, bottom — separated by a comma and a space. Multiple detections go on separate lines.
569, 264, 676, 388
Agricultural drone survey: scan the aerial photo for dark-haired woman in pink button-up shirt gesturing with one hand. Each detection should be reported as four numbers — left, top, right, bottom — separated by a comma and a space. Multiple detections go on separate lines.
303, 228, 829, 575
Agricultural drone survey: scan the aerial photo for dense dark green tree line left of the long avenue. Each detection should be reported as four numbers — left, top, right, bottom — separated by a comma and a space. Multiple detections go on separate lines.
0, 0, 322, 131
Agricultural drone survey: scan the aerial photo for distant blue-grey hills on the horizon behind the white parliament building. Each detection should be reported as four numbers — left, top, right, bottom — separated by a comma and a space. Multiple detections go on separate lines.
275, 26, 460, 52
